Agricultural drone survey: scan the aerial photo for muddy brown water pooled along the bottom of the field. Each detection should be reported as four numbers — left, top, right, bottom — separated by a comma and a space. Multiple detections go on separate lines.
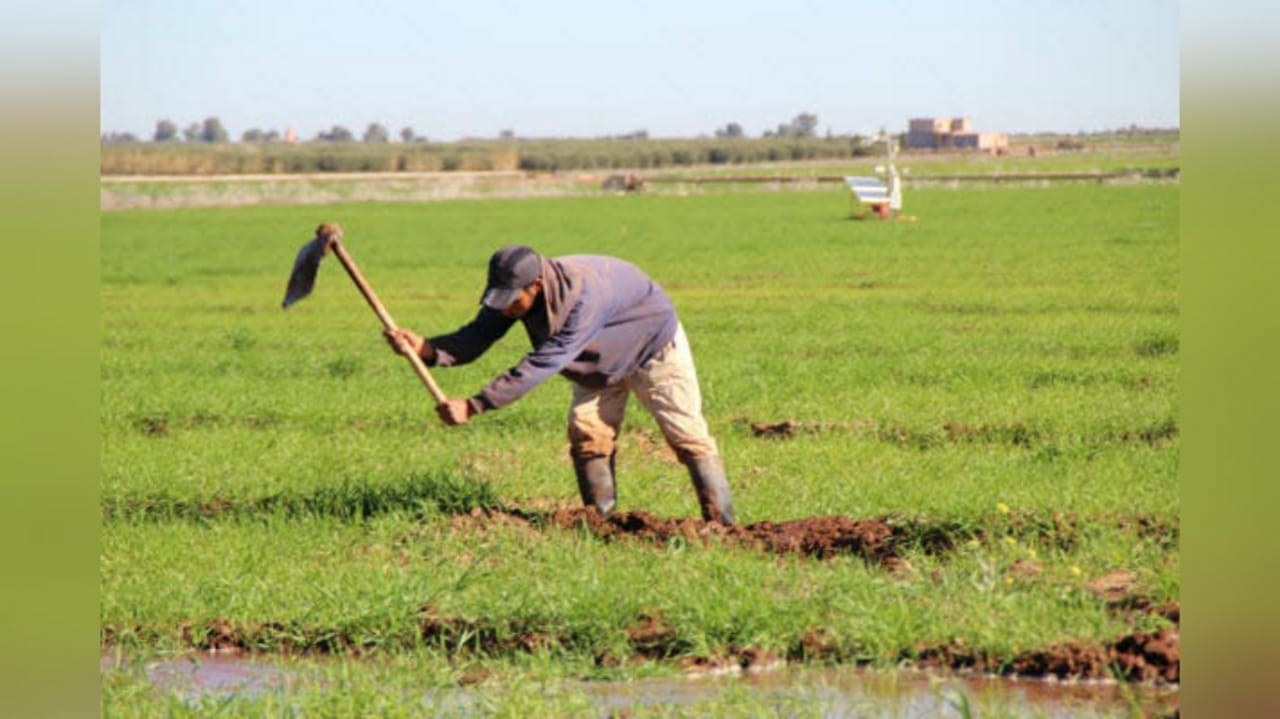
101, 654, 1178, 719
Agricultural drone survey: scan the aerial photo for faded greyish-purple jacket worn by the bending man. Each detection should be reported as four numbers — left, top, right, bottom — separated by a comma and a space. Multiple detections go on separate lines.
429, 255, 678, 411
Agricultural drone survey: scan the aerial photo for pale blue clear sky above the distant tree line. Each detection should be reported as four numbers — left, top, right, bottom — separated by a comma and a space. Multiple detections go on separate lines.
99, 0, 1179, 139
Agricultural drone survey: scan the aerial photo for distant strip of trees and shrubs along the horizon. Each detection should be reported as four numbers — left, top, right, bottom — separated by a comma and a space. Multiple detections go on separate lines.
101, 113, 1178, 174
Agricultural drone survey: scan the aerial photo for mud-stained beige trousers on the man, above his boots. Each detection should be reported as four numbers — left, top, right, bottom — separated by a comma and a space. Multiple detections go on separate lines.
568, 325, 719, 463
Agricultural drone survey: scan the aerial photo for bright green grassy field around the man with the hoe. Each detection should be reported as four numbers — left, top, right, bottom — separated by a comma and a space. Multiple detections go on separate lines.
100, 186, 1180, 715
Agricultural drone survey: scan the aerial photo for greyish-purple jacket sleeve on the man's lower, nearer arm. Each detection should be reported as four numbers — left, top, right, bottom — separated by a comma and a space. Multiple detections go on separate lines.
472, 299, 607, 409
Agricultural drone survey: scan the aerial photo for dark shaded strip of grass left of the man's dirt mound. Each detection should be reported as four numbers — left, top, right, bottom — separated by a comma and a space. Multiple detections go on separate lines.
102, 472, 502, 522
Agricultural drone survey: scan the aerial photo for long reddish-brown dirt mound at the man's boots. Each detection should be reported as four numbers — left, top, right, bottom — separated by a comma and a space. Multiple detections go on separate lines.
522, 508, 900, 565
